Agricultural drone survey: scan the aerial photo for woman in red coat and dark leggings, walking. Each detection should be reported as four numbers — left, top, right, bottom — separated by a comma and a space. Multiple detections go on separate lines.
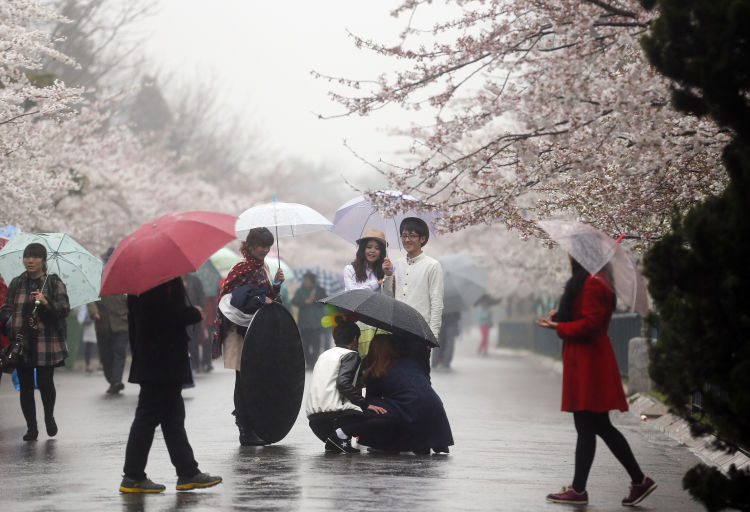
537, 257, 656, 506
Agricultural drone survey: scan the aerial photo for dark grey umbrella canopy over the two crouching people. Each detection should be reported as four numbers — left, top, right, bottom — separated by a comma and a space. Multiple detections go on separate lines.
320, 290, 438, 347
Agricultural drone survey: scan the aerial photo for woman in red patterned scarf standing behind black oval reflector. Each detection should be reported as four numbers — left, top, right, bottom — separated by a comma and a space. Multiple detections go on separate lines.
213, 228, 284, 446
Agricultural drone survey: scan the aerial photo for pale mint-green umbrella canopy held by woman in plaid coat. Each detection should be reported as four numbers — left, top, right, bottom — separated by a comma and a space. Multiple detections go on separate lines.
0, 232, 102, 308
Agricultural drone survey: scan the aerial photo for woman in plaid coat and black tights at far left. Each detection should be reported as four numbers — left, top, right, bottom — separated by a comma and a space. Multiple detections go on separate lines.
0, 243, 70, 441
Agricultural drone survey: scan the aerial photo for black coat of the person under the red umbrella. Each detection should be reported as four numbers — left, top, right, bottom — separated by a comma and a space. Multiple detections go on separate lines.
128, 278, 201, 384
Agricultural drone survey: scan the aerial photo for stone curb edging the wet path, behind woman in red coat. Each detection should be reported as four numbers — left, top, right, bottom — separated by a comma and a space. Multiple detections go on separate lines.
500, 348, 750, 473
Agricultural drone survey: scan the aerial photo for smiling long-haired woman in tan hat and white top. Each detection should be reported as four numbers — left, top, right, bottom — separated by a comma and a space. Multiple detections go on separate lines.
344, 228, 388, 357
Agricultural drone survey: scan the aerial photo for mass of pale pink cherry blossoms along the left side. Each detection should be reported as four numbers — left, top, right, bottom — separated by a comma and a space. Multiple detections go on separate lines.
0, 0, 270, 254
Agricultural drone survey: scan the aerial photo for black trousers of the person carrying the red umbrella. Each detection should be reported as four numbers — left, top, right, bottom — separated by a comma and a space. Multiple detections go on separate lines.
123, 382, 199, 480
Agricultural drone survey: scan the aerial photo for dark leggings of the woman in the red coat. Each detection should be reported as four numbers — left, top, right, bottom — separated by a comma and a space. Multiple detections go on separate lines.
573, 411, 643, 492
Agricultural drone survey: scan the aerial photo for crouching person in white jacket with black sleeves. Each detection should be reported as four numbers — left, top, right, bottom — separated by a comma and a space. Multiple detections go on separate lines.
305, 321, 386, 453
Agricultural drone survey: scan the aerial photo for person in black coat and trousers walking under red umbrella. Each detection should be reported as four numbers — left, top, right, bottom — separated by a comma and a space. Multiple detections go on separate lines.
120, 277, 221, 493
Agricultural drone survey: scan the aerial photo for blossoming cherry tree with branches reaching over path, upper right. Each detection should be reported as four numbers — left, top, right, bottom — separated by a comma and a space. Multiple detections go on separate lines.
318, 0, 728, 248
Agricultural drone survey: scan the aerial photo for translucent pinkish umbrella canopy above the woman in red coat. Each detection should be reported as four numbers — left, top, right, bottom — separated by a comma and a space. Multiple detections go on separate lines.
539, 220, 648, 316
